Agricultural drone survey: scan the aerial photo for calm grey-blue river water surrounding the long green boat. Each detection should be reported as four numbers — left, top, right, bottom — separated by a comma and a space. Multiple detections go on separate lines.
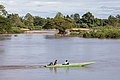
0, 31, 120, 80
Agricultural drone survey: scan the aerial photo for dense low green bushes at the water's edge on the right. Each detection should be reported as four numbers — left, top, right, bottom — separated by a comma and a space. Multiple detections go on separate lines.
81, 27, 120, 39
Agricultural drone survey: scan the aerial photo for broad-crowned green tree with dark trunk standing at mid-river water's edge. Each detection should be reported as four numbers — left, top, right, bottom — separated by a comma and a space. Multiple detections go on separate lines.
43, 18, 76, 34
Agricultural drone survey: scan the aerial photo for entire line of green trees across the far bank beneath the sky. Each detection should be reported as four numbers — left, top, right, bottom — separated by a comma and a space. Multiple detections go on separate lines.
0, 5, 120, 37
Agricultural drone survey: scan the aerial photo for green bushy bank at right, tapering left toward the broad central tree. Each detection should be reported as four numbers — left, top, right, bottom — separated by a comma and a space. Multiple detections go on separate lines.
70, 27, 120, 39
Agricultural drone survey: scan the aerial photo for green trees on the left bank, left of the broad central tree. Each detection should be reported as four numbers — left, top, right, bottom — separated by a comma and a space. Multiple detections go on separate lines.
0, 5, 46, 34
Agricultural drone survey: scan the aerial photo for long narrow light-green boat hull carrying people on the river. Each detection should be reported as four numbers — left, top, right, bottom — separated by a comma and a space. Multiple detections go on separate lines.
46, 62, 95, 68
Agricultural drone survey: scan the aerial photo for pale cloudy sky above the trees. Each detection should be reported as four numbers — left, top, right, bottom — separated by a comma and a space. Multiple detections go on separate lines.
0, 0, 120, 18
